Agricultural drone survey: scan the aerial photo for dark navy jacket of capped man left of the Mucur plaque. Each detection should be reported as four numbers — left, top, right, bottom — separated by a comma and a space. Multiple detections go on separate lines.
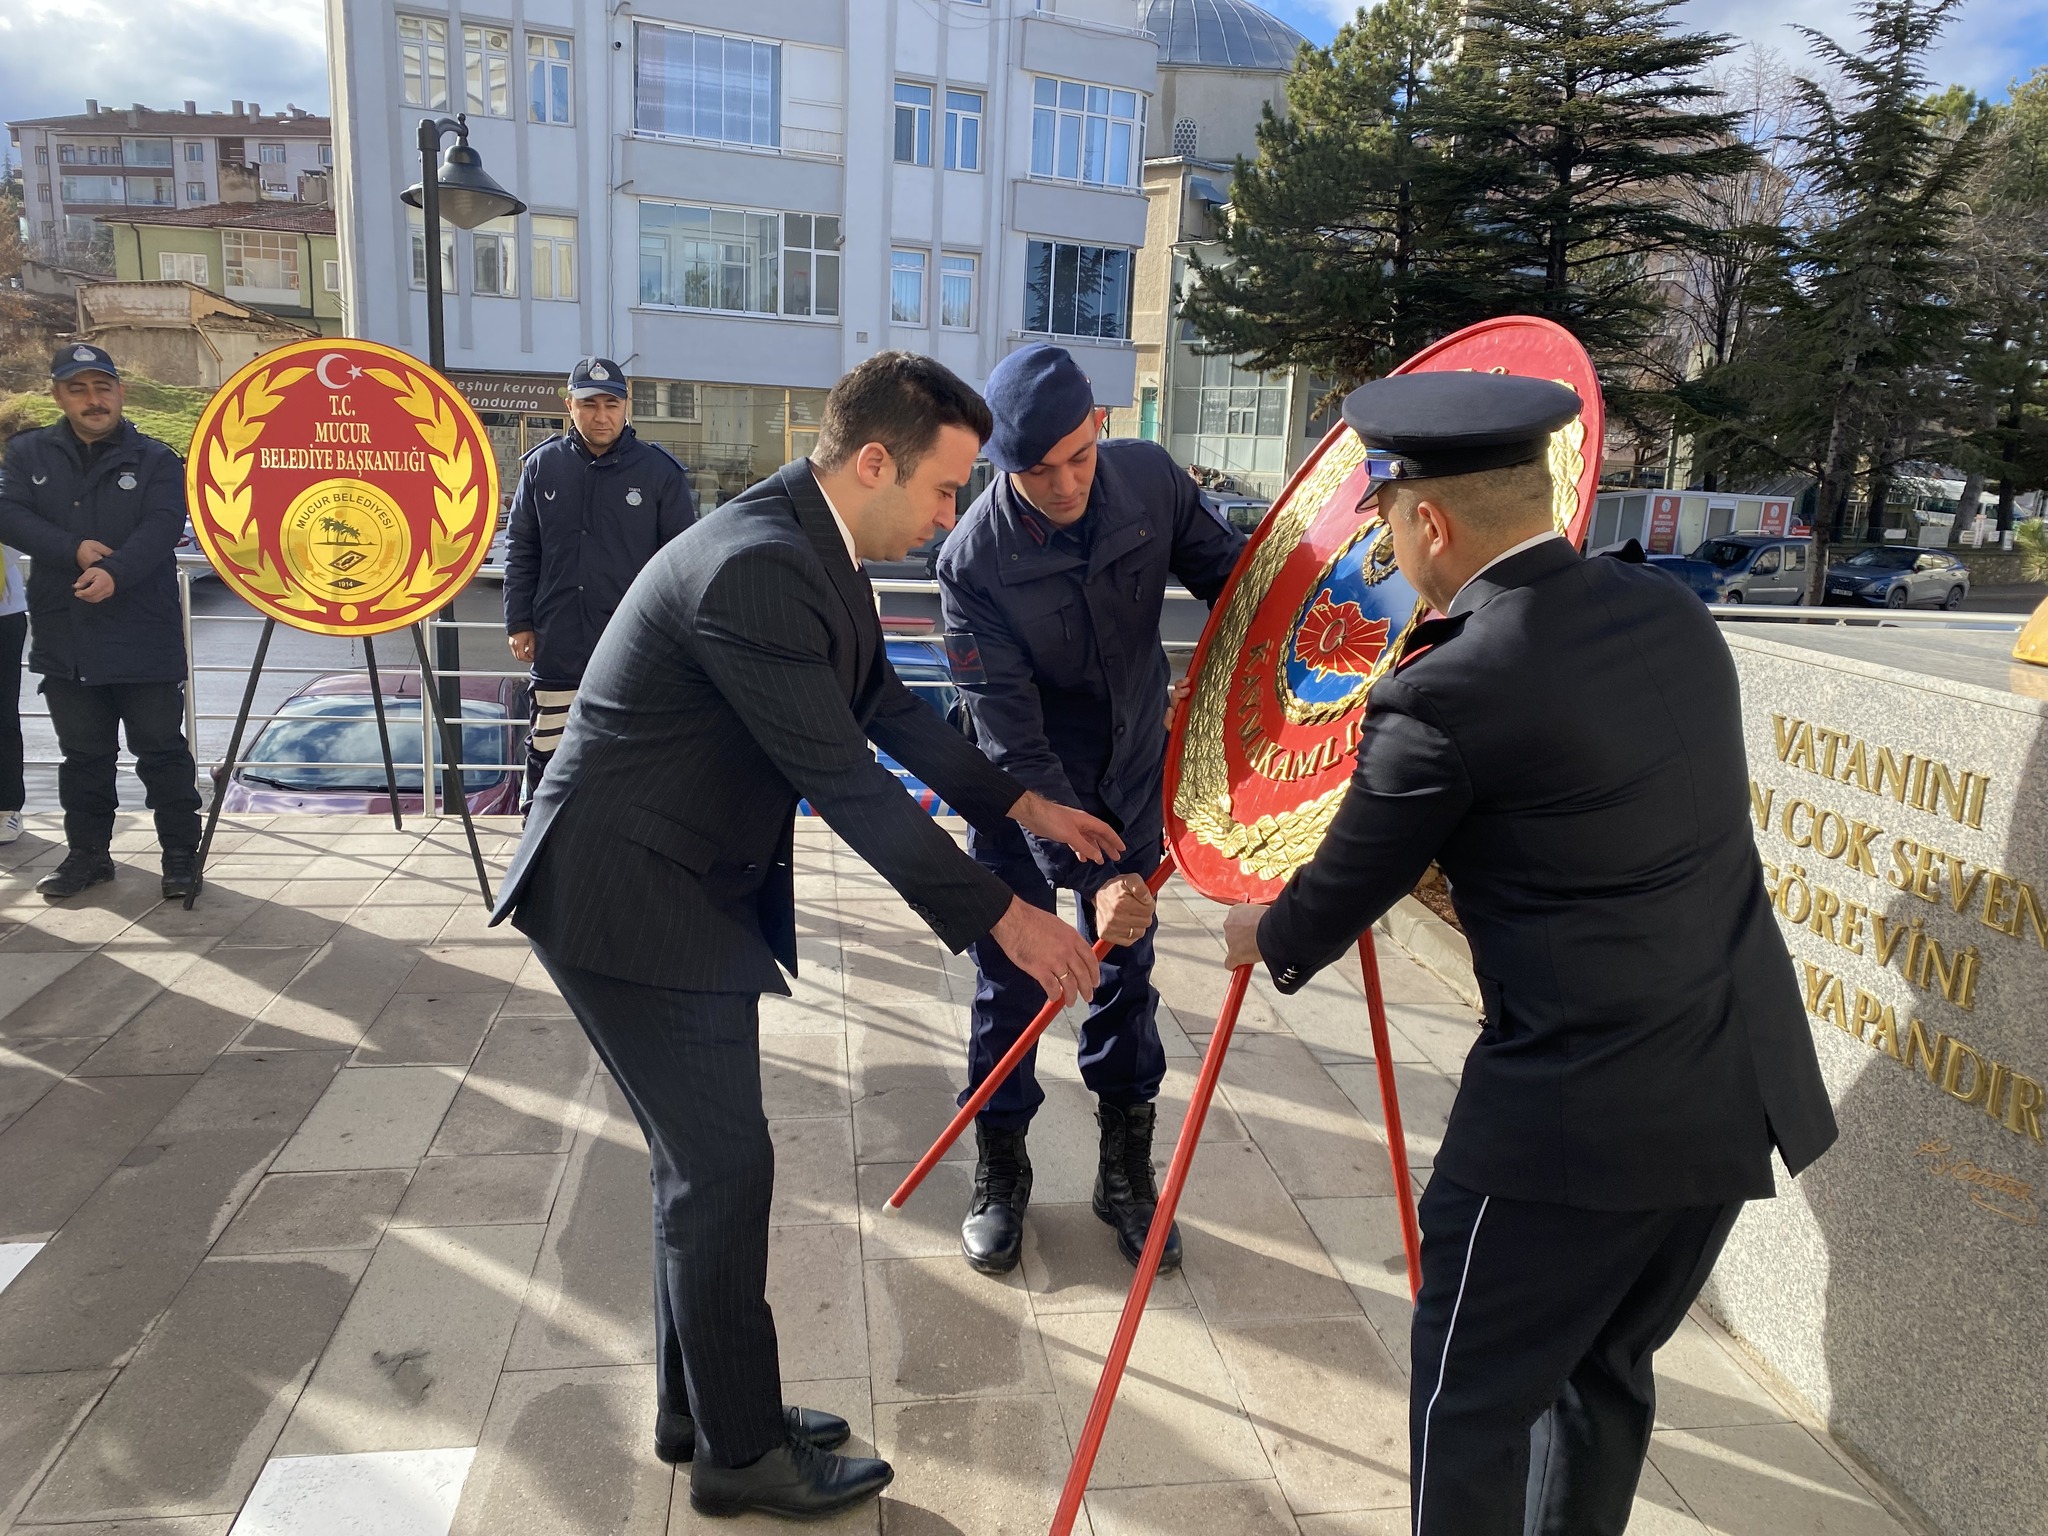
0, 422, 184, 684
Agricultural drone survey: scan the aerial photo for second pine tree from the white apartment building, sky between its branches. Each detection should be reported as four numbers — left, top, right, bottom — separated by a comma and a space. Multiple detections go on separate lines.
1432, 0, 1755, 412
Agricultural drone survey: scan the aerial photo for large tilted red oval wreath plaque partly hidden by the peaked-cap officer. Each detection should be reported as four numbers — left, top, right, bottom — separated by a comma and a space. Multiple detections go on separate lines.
1165, 315, 1602, 901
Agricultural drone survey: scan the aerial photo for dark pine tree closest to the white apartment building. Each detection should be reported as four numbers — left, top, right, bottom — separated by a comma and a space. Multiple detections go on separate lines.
1182, 0, 1497, 383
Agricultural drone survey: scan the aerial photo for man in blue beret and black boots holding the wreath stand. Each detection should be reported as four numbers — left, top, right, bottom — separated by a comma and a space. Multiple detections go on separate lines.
938, 346, 1245, 1274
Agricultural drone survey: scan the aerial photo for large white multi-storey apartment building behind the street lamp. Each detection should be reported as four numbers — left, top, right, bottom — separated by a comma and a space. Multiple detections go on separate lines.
328, 0, 1159, 506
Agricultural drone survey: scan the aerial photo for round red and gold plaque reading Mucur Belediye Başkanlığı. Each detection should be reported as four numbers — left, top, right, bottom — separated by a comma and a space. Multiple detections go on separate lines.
184, 340, 498, 635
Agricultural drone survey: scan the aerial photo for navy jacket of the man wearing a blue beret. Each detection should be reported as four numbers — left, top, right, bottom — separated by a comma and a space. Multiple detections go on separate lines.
938, 440, 1245, 891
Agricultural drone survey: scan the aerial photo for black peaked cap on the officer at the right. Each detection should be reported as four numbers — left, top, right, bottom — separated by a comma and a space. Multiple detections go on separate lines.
1343, 373, 1579, 487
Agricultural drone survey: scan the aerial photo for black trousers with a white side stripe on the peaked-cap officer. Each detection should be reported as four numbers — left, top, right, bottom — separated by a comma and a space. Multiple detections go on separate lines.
1409, 1174, 1743, 1536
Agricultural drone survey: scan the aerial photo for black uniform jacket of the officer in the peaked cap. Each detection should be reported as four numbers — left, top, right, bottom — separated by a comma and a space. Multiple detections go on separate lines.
1260, 539, 1835, 1210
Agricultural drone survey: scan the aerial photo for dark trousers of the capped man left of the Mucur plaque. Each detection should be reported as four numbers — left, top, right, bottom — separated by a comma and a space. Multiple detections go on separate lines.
43, 678, 201, 850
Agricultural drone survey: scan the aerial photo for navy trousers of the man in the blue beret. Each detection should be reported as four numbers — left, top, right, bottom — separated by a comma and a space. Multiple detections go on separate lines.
958, 829, 1165, 1130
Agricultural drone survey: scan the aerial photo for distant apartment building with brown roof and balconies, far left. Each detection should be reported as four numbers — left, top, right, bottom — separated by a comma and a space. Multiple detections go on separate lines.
8, 100, 334, 272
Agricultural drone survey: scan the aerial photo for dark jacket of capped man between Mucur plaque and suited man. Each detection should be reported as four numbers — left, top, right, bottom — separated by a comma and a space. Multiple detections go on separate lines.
506, 426, 696, 688
